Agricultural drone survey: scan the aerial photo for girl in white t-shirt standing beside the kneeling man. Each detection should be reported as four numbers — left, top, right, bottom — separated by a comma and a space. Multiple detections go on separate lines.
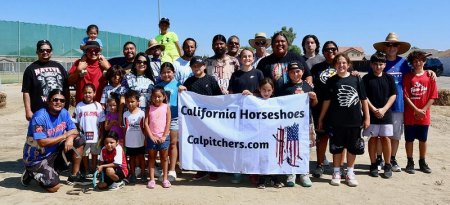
75, 83, 103, 178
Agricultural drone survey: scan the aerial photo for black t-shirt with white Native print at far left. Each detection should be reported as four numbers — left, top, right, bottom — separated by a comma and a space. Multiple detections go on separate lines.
22, 61, 70, 113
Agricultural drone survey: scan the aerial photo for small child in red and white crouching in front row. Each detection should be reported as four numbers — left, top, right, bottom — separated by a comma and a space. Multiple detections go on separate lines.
97, 131, 128, 190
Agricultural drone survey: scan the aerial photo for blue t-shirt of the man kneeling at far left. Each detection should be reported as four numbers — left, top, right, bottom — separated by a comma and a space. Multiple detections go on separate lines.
23, 108, 76, 166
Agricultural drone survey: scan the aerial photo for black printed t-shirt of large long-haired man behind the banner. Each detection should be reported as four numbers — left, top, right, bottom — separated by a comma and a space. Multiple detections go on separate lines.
257, 52, 311, 96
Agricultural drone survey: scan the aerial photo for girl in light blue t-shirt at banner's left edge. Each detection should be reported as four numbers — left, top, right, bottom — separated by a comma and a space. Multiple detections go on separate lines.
158, 62, 181, 181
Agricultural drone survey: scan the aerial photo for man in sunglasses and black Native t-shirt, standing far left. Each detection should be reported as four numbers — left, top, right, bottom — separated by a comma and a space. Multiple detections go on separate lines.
22, 40, 69, 121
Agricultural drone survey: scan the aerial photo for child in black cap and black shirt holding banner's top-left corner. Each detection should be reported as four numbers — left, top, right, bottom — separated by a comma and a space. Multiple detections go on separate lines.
178, 56, 222, 182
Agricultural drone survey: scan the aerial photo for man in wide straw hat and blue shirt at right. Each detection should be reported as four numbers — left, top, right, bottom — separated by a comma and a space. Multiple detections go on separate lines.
373, 32, 436, 172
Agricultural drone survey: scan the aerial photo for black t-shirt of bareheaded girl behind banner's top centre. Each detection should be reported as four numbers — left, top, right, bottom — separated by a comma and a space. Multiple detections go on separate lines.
228, 68, 264, 93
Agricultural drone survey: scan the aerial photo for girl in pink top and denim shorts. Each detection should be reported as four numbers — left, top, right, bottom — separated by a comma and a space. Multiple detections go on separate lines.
144, 86, 171, 189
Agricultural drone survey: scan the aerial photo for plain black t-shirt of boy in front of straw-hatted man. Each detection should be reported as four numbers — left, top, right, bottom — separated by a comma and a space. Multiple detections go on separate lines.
363, 72, 397, 124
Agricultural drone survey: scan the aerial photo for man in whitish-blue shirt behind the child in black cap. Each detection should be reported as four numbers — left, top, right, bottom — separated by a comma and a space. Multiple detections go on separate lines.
173, 38, 197, 84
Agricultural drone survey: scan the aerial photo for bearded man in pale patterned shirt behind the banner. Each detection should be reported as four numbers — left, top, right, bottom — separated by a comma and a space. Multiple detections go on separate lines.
205, 34, 239, 94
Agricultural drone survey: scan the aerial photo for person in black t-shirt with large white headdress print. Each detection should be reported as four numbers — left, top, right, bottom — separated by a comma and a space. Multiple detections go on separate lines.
318, 53, 370, 187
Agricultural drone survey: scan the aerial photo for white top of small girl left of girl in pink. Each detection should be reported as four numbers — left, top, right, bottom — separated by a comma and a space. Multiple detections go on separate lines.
123, 109, 145, 148
